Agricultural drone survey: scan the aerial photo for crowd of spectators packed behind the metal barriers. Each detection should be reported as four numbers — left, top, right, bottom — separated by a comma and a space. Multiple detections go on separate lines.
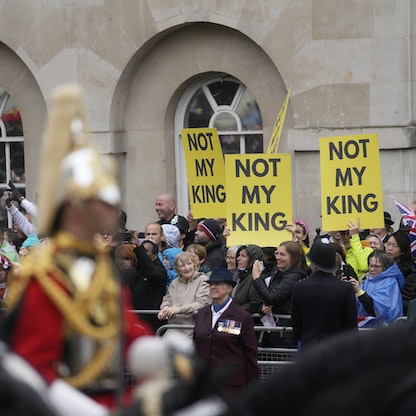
0, 182, 416, 354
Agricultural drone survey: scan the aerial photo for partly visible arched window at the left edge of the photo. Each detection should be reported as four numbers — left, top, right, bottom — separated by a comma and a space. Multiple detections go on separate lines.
0, 87, 26, 226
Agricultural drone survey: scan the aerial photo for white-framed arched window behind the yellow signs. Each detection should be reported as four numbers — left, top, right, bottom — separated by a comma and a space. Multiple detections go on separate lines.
175, 74, 263, 215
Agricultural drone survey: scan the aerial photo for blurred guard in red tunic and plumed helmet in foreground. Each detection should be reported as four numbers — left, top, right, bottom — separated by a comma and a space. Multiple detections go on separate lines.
3, 85, 151, 416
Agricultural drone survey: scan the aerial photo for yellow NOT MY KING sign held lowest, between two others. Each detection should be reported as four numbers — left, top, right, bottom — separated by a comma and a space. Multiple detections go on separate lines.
225, 154, 292, 247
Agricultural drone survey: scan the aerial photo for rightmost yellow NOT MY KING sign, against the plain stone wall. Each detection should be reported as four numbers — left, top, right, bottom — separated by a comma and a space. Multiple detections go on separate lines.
320, 134, 384, 231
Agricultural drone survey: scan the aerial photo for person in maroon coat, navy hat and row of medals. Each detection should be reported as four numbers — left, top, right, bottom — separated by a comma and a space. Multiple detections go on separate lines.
194, 268, 260, 393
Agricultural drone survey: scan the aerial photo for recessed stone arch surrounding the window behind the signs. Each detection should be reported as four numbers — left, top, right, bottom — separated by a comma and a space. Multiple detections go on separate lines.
111, 23, 291, 228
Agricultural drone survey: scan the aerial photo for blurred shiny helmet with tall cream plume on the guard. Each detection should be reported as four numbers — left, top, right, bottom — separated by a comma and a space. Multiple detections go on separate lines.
38, 84, 120, 235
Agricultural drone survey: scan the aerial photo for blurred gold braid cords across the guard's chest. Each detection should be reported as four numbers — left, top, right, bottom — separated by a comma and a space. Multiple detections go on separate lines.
7, 233, 121, 388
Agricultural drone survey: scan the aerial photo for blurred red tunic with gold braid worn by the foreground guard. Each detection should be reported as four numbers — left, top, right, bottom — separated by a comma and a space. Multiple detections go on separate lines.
7, 233, 151, 406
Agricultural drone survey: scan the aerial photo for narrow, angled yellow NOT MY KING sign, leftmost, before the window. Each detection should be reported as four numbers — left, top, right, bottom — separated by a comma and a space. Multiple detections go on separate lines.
182, 128, 226, 218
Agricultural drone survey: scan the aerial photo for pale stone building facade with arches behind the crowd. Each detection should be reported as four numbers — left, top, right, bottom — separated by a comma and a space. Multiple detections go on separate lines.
0, 0, 416, 237
